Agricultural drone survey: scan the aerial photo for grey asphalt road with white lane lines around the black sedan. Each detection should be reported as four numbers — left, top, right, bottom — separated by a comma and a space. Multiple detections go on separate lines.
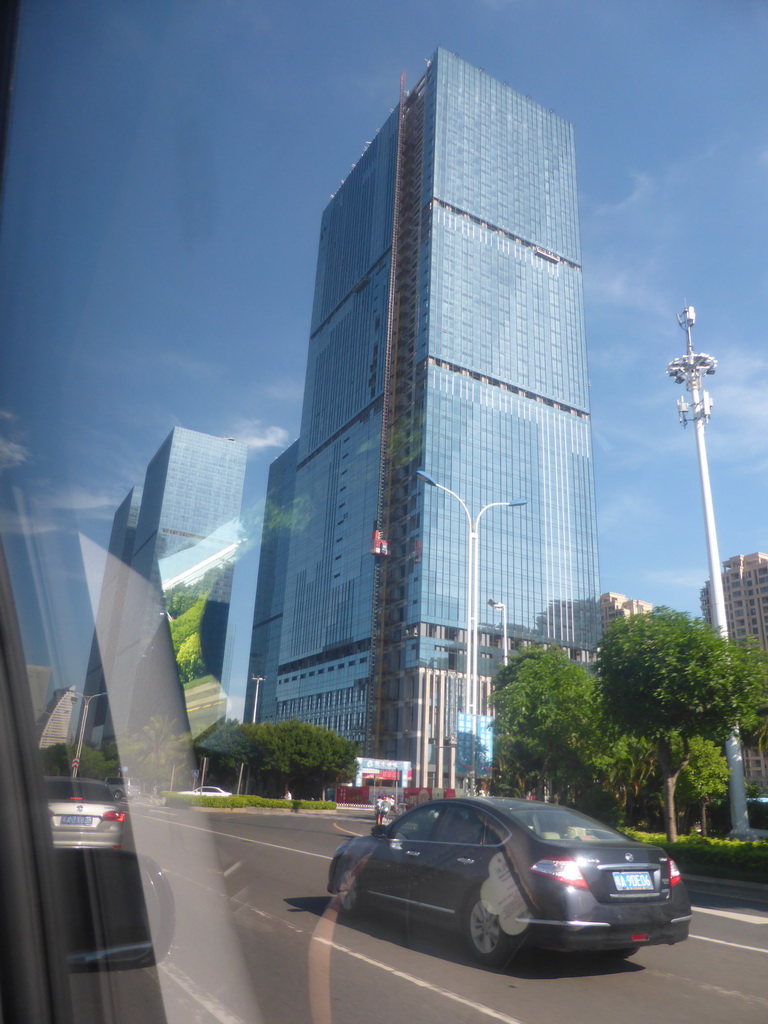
73, 803, 768, 1024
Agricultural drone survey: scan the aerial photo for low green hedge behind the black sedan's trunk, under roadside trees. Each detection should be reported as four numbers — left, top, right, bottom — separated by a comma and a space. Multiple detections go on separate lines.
622, 828, 768, 883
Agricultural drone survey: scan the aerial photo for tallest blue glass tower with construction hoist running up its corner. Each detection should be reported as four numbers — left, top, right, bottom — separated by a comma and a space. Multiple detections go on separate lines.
251, 49, 599, 786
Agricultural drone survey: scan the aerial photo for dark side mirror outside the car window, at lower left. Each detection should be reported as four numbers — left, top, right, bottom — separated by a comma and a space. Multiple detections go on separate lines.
53, 848, 175, 971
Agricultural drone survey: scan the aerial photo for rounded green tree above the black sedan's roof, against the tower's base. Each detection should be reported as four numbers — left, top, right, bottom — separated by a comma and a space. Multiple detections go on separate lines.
493, 647, 602, 799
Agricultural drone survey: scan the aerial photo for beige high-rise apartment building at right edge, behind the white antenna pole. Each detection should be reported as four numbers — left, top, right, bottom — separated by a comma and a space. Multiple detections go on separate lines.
701, 551, 768, 792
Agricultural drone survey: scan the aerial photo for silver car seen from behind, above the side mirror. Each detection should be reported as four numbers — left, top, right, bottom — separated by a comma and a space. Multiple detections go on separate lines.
45, 775, 126, 850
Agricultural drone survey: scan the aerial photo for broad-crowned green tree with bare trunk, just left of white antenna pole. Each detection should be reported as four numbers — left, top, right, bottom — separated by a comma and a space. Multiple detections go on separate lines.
598, 607, 766, 841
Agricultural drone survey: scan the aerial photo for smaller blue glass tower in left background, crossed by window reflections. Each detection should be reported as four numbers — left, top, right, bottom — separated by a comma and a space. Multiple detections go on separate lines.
85, 427, 247, 741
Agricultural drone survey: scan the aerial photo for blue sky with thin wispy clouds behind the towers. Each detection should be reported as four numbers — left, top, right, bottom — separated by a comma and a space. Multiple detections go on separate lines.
0, 0, 768, 716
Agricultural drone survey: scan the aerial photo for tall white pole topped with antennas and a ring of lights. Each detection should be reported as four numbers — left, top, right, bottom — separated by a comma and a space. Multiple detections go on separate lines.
667, 306, 750, 835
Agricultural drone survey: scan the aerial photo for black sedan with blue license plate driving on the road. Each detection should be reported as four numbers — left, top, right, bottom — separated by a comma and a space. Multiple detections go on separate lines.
328, 798, 690, 967
